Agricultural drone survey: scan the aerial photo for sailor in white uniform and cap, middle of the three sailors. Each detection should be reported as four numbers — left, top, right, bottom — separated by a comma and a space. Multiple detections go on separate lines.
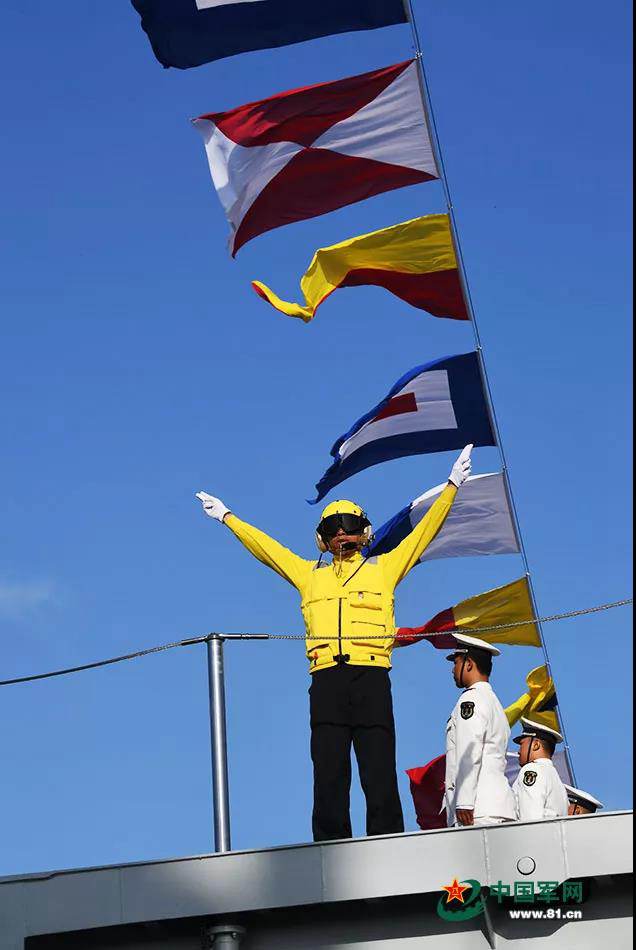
512, 718, 569, 821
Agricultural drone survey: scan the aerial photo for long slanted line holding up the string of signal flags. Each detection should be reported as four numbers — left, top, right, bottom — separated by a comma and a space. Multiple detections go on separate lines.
404, 0, 576, 785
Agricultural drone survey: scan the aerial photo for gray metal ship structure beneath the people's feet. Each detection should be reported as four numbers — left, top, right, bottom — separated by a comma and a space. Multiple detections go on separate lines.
0, 812, 633, 950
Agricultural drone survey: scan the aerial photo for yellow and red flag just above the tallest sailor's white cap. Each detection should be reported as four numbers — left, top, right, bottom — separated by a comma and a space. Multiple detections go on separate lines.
395, 577, 541, 650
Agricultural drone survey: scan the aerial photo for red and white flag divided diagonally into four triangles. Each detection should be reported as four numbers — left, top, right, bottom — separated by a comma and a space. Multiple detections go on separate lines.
193, 60, 439, 256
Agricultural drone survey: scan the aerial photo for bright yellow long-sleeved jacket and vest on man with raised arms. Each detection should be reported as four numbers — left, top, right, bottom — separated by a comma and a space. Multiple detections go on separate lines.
225, 484, 457, 673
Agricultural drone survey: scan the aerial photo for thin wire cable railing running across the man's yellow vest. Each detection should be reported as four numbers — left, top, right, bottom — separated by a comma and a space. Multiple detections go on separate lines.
0, 597, 633, 686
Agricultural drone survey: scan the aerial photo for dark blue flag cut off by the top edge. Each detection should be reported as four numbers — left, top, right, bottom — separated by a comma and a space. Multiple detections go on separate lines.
132, 0, 407, 69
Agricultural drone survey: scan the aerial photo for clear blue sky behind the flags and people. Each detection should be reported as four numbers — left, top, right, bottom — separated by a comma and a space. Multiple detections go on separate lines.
0, 0, 632, 874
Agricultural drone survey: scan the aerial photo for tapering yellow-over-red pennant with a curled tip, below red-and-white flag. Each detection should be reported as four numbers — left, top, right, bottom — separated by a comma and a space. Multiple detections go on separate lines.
252, 214, 469, 323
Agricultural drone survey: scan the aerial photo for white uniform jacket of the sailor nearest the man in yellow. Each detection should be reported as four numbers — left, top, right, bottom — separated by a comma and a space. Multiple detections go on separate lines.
445, 682, 516, 827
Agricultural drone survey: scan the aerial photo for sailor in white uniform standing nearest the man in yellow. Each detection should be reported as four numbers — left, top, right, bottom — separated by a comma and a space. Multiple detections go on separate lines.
445, 633, 515, 827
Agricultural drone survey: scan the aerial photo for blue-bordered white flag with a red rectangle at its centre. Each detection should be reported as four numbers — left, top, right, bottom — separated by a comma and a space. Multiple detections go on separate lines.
313, 353, 496, 504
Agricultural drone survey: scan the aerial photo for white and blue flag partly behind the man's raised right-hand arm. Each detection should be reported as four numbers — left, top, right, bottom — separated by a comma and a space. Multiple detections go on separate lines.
365, 473, 520, 562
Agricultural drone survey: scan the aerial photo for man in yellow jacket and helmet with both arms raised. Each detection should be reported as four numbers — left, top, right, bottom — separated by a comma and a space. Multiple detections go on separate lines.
197, 445, 472, 841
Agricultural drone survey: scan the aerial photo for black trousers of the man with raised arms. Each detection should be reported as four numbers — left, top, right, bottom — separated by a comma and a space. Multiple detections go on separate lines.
309, 664, 404, 841
